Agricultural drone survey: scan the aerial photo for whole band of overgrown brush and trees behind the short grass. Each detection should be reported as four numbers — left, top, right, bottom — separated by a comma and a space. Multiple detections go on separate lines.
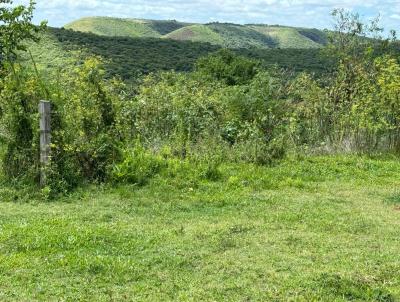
0, 3, 400, 198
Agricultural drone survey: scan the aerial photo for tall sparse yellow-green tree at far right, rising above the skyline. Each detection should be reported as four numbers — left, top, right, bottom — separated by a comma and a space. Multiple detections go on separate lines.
324, 10, 398, 150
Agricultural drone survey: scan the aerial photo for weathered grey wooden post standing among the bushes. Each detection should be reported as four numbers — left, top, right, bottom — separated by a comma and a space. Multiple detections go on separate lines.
39, 101, 51, 187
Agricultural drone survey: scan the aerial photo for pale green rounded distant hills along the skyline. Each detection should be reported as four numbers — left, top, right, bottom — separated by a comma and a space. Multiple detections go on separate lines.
65, 17, 326, 49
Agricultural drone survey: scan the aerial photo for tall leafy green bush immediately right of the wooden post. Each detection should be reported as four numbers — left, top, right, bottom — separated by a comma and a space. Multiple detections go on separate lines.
52, 58, 129, 181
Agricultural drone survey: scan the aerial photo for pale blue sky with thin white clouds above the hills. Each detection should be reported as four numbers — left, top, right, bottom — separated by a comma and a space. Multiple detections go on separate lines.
10, 0, 400, 32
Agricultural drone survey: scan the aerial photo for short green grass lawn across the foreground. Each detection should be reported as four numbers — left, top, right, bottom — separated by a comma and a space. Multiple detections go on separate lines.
0, 157, 400, 301
